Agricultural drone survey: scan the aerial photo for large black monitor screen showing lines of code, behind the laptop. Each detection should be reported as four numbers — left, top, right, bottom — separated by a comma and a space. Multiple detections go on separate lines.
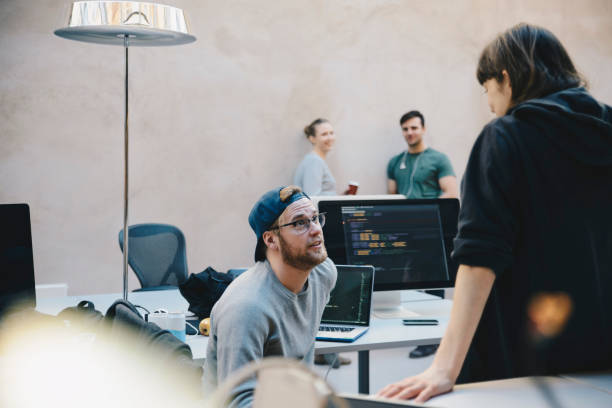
319, 199, 459, 291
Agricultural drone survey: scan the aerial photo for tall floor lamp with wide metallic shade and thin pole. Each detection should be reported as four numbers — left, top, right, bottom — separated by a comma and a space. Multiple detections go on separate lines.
55, 1, 196, 300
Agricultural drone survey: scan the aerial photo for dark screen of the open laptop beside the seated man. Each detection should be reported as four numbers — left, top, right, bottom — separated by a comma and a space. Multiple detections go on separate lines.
321, 265, 374, 326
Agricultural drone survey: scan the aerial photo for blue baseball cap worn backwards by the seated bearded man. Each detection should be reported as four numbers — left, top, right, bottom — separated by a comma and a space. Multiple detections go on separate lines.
249, 186, 310, 261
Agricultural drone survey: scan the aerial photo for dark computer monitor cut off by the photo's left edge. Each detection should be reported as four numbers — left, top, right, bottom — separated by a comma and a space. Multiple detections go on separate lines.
0, 204, 36, 317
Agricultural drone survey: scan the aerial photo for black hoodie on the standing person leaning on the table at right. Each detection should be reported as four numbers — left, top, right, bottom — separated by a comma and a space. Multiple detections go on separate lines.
453, 88, 612, 382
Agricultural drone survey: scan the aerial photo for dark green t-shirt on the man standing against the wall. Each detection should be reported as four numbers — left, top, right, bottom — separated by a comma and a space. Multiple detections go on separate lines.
387, 148, 455, 198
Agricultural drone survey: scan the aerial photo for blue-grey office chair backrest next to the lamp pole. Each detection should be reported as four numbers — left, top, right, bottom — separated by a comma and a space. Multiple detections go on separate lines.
119, 224, 187, 292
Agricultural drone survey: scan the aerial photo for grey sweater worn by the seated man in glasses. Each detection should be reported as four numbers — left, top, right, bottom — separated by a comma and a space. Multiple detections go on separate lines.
204, 258, 337, 407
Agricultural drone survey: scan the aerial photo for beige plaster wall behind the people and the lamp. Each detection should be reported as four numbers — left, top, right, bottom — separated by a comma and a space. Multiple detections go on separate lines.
0, 0, 612, 294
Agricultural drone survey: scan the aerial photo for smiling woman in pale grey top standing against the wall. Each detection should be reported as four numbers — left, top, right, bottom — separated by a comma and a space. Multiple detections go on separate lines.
293, 118, 336, 196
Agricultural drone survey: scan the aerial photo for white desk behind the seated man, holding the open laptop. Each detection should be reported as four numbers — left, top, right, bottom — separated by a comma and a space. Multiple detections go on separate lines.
36, 290, 452, 394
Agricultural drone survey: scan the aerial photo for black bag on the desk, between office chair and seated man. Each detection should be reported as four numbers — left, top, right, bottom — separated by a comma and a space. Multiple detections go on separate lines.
179, 266, 234, 320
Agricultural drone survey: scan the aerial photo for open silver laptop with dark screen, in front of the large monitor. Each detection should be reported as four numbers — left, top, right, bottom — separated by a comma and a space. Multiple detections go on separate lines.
317, 265, 374, 343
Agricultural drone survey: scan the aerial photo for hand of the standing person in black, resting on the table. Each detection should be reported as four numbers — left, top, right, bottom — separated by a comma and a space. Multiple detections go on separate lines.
376, 366, 455, 403
